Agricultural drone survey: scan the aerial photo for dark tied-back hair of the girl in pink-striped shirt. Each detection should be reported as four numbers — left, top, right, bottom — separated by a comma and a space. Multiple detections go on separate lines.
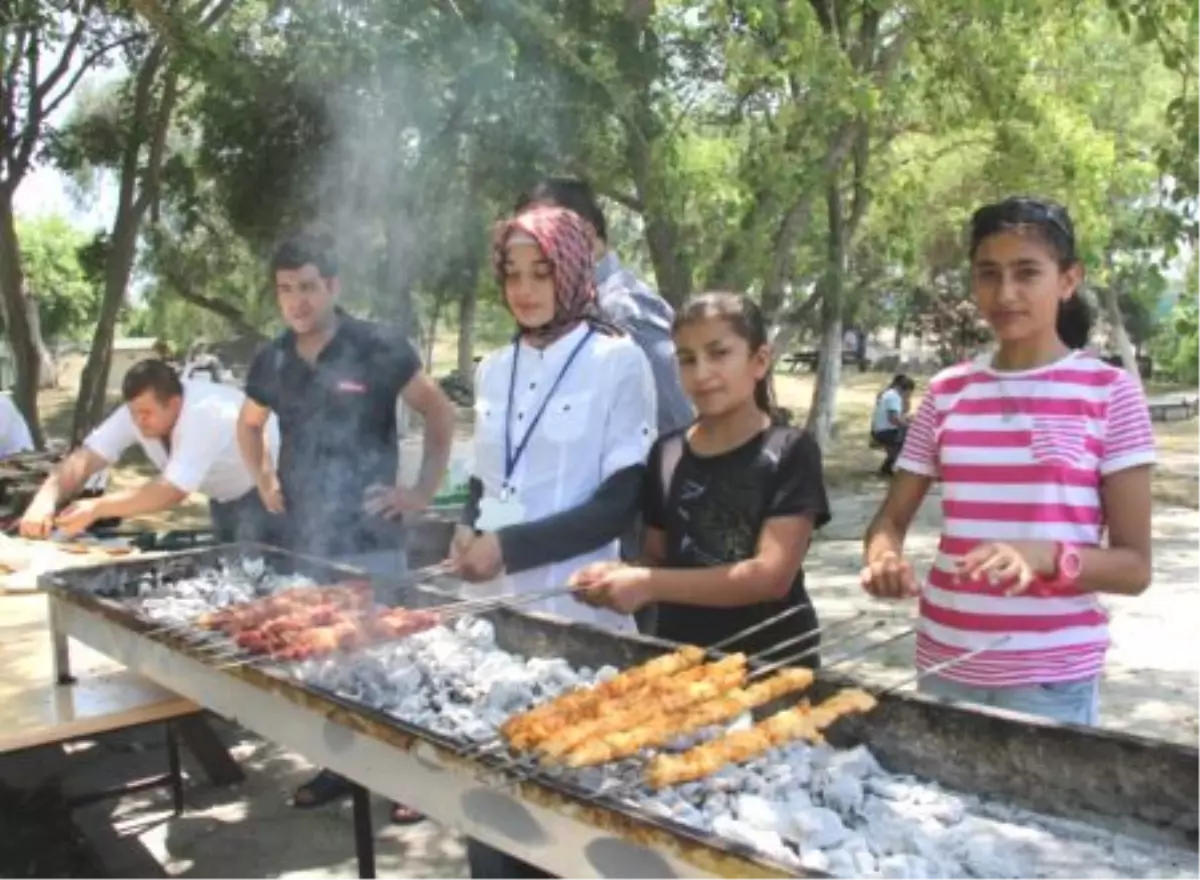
971, 196, 1094, 348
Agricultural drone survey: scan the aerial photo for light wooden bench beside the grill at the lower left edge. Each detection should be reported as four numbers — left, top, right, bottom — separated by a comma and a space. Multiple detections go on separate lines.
0, 670, 203, 815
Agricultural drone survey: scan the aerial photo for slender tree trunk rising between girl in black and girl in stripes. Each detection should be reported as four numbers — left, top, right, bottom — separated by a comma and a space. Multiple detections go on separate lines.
808, 181, 846, 449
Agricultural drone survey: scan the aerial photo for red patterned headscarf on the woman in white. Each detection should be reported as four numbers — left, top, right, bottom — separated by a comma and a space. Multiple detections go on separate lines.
492, 206, 620, 341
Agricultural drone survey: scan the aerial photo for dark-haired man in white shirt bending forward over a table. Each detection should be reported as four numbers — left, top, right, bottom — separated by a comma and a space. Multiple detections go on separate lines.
20, 360, 278, 543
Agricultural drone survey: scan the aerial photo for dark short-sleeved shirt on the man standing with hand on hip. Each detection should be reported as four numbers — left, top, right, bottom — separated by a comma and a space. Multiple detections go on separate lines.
246, 312, 421, 556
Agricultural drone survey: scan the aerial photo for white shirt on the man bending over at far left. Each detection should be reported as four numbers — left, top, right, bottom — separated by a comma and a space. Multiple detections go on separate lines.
84, 381, 280, 502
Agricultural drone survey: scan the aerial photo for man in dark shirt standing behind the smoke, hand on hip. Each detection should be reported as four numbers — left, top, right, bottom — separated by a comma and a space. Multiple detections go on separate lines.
237, 234, 454, 824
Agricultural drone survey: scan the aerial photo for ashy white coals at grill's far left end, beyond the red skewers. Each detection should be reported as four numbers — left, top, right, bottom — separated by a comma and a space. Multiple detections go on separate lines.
132, 558, 316, 624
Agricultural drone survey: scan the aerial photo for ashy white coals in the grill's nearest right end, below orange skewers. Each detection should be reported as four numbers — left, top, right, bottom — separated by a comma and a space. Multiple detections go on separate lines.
629, 743, 1200, 880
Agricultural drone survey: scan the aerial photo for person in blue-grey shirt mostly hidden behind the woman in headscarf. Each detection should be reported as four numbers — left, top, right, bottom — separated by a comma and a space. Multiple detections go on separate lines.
515, 178, 695, 633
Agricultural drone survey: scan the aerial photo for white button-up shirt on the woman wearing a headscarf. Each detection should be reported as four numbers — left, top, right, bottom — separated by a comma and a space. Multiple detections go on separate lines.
474, 325, 658, 631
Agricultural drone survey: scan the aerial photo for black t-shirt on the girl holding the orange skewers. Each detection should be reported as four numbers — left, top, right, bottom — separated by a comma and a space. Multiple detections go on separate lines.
643, 426, 829, 666
